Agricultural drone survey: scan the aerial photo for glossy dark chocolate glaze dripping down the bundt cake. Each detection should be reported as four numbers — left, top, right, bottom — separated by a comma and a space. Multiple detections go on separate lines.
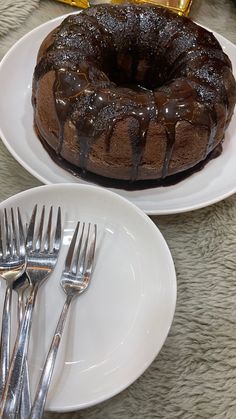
33, 5, 236, 187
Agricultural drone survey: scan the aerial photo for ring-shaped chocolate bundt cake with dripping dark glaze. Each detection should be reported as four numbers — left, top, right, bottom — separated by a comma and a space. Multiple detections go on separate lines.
32, 4, 236, 187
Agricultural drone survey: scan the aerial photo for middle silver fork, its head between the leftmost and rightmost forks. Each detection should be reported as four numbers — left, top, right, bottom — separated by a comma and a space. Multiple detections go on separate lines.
0, 205, 61, 419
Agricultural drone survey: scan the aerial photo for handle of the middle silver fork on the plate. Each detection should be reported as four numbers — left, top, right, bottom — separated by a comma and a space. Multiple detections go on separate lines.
0, 287, 38, 419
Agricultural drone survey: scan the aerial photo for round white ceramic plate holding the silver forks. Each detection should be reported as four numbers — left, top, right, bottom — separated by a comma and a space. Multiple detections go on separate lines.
0, 184, 176, 411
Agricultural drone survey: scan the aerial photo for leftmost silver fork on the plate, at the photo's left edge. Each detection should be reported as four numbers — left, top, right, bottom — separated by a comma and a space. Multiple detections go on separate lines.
0, 208, 25, 395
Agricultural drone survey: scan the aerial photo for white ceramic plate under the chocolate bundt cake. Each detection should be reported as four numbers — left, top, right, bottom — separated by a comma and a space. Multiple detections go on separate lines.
0, 16, 236, 214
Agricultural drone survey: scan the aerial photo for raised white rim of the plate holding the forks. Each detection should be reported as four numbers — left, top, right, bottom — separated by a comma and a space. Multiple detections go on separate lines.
0, 183, 177, 413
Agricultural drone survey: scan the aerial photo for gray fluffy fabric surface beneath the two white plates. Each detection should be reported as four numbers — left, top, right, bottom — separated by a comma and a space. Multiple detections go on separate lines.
0, 0, 236, 419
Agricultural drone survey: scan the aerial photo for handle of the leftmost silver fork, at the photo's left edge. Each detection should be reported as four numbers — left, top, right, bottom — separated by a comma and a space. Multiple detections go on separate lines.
0, 285, 12, 395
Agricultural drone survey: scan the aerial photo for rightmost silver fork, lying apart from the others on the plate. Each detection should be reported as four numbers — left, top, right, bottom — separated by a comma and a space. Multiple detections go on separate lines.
30, 223, 97, 419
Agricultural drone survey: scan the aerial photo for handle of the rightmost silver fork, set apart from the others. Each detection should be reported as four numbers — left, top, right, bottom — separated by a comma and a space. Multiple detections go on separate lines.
29, 294, 73, 419
